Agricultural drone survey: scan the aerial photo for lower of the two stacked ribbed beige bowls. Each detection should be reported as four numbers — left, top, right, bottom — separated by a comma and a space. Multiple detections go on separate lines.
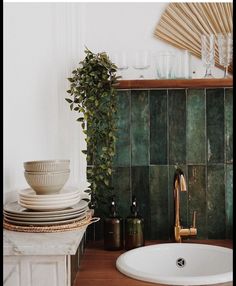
24, 171, 70, 195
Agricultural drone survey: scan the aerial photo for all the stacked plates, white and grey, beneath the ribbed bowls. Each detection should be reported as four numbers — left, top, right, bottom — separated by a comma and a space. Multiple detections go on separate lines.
3, 187, 89, 226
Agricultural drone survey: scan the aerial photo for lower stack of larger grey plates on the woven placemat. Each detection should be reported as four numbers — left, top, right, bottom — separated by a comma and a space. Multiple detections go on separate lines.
3, 200, 89, 226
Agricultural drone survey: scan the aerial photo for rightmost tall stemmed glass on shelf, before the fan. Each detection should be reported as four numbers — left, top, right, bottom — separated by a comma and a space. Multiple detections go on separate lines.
217, 33, 233, 78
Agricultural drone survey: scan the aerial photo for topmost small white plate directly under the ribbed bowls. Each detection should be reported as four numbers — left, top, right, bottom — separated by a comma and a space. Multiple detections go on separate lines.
18, 187, 81, 199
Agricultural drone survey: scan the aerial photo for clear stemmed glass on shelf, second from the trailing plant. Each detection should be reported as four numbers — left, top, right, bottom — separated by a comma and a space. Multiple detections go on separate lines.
132, 50, 151, 79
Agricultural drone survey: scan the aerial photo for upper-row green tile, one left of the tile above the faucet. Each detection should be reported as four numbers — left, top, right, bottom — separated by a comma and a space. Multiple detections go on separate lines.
150, 90, 168, 165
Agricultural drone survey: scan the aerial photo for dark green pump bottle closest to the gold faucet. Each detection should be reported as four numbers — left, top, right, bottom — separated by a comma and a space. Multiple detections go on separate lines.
125, 196, 145, 250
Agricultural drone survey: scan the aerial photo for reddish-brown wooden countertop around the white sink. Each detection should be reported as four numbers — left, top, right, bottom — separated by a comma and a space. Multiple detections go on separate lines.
73, 240, 233, 286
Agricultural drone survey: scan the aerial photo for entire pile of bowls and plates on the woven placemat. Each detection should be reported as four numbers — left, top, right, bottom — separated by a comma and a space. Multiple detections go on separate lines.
3, 160, 92, 227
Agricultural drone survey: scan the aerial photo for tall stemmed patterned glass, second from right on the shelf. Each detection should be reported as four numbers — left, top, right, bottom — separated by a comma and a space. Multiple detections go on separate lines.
201, 34, 215, 78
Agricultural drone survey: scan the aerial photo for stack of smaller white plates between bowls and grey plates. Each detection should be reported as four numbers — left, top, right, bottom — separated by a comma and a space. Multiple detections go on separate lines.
18, 187, 82, 211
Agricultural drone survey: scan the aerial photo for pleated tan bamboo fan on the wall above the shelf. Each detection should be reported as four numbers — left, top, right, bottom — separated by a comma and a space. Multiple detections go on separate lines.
154, 2, 233, 73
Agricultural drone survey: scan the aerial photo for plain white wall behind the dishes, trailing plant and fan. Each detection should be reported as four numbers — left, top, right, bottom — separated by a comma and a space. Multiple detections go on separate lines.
3, 2, 225, 198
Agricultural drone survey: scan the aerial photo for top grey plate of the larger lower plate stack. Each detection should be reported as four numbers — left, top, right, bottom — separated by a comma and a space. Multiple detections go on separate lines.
3, 200, 88, 215
